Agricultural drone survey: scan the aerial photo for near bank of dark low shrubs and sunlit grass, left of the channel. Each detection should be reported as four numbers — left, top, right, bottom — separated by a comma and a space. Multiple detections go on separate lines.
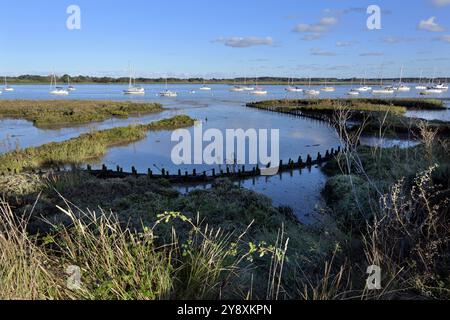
0, 173, 337, 299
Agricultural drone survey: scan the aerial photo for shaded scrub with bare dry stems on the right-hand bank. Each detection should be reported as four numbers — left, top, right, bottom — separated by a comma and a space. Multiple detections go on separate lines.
320, 105, 450, 299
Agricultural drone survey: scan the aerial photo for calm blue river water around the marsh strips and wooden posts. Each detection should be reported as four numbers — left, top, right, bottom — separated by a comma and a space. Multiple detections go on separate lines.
0, 85, 450, 221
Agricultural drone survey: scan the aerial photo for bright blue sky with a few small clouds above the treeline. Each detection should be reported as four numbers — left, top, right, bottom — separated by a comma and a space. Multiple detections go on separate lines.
0, 0, 450, 77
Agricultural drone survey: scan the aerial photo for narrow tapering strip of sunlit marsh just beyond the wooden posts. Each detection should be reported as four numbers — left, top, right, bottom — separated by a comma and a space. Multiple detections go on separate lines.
0, 115, 194, 172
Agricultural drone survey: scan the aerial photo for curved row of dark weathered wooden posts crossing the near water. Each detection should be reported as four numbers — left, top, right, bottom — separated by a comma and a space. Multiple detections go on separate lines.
85, 147, 341, 183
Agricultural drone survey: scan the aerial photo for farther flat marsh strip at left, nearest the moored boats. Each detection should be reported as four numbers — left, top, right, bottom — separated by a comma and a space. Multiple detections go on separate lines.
0, 100, 163, 127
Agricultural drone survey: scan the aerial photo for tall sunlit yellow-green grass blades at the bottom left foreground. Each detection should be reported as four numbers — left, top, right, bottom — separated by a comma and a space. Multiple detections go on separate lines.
0, 199, 287, 300
